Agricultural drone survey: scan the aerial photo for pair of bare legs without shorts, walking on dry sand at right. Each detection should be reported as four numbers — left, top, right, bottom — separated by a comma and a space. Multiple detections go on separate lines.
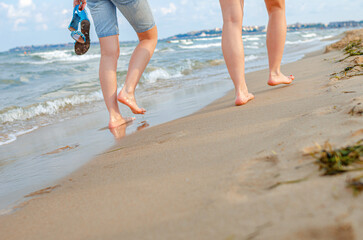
219, 0, 294, 105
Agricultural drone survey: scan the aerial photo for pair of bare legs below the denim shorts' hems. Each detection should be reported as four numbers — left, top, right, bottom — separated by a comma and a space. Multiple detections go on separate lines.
99, 26, 157, 128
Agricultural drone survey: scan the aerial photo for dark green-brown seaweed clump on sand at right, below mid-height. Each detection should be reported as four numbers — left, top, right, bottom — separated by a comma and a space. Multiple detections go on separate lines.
311, 139, 363, 176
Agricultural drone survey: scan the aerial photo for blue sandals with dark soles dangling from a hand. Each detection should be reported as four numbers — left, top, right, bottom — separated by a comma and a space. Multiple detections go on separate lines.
68, 5, 91, 55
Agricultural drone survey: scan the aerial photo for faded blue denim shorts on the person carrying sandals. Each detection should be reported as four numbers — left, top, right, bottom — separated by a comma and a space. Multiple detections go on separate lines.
87, 0, 155, 38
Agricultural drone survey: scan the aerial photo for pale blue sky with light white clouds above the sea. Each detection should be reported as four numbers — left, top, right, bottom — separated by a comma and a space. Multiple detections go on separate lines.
0, 0, 363, 51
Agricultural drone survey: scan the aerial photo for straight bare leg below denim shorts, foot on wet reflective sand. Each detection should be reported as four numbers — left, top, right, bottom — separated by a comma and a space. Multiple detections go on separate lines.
99, 35, 133, 128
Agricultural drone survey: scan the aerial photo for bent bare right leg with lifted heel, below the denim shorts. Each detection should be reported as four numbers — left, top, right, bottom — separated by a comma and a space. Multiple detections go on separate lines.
117, 26, 158, 114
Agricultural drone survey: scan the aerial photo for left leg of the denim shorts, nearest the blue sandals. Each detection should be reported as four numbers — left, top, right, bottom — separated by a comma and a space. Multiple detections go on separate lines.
87, 0, 119, 38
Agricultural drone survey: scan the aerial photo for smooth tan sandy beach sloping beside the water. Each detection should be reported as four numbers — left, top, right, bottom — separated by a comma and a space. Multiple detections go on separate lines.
0, 29, 363, 240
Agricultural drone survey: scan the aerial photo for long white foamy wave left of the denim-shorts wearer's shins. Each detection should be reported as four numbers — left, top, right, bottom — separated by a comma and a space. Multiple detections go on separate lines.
0, 91, 103, 123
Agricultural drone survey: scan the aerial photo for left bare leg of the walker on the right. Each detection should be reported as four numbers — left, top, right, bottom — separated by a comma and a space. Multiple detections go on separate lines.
219, 0, 254, 105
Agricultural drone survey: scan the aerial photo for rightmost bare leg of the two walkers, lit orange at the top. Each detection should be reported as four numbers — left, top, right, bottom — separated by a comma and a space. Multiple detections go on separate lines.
265, 0, 294, 86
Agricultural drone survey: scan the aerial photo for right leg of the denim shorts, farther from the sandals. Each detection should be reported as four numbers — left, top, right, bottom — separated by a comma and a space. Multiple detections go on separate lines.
112, 0, 155, 33
